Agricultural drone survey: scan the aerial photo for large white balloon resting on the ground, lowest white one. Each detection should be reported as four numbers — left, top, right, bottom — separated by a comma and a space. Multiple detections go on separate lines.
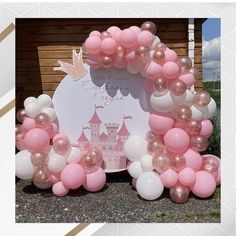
136, 171, 164, 200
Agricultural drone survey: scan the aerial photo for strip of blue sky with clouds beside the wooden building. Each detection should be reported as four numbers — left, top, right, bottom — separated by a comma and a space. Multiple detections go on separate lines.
202, 18, 220, 81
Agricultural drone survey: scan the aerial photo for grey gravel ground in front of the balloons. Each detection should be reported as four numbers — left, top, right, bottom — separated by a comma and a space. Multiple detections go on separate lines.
16, 173, 220, 223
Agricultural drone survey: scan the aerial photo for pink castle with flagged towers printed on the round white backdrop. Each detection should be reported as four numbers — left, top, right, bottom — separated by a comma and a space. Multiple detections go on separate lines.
76, 105, 132, 170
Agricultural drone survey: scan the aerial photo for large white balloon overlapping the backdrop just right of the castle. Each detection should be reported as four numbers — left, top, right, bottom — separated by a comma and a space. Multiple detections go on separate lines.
124, 136, 147, 161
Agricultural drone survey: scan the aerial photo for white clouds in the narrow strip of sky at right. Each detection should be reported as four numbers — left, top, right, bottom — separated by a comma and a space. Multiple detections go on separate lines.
202, 37, 220, 81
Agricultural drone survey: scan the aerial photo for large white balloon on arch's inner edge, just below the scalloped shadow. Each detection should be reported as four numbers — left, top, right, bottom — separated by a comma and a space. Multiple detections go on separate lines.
150, 92, 174, 112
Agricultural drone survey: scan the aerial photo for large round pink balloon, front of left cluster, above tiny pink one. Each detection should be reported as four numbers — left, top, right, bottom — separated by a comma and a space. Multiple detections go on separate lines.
61, 163, 86, 189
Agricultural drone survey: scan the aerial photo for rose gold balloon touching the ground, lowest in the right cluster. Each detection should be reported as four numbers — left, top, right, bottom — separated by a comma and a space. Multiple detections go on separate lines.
170, 183, 189, 203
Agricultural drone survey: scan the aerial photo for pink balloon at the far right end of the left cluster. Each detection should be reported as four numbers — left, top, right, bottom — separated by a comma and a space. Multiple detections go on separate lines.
83, 167, 106, 192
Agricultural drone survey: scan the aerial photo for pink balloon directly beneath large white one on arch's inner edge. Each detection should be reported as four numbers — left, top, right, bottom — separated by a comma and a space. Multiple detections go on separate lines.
148, 114, 174, 134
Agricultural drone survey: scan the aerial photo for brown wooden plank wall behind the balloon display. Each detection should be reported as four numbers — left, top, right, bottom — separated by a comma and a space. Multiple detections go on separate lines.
16, 18, 202, 107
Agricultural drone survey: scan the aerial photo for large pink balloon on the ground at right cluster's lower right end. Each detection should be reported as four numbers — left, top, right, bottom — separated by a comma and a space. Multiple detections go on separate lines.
191, 171, 216, 198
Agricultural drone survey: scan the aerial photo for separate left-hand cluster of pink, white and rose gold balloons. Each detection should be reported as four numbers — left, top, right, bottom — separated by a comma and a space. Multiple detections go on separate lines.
15, 94, 106, 196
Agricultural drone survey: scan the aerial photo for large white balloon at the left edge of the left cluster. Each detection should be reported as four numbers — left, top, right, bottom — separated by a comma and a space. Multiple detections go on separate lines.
15, 150, 35, 179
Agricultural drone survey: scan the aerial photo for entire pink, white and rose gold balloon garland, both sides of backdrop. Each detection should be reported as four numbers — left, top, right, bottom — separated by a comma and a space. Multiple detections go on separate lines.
16, 21, 220, 203
